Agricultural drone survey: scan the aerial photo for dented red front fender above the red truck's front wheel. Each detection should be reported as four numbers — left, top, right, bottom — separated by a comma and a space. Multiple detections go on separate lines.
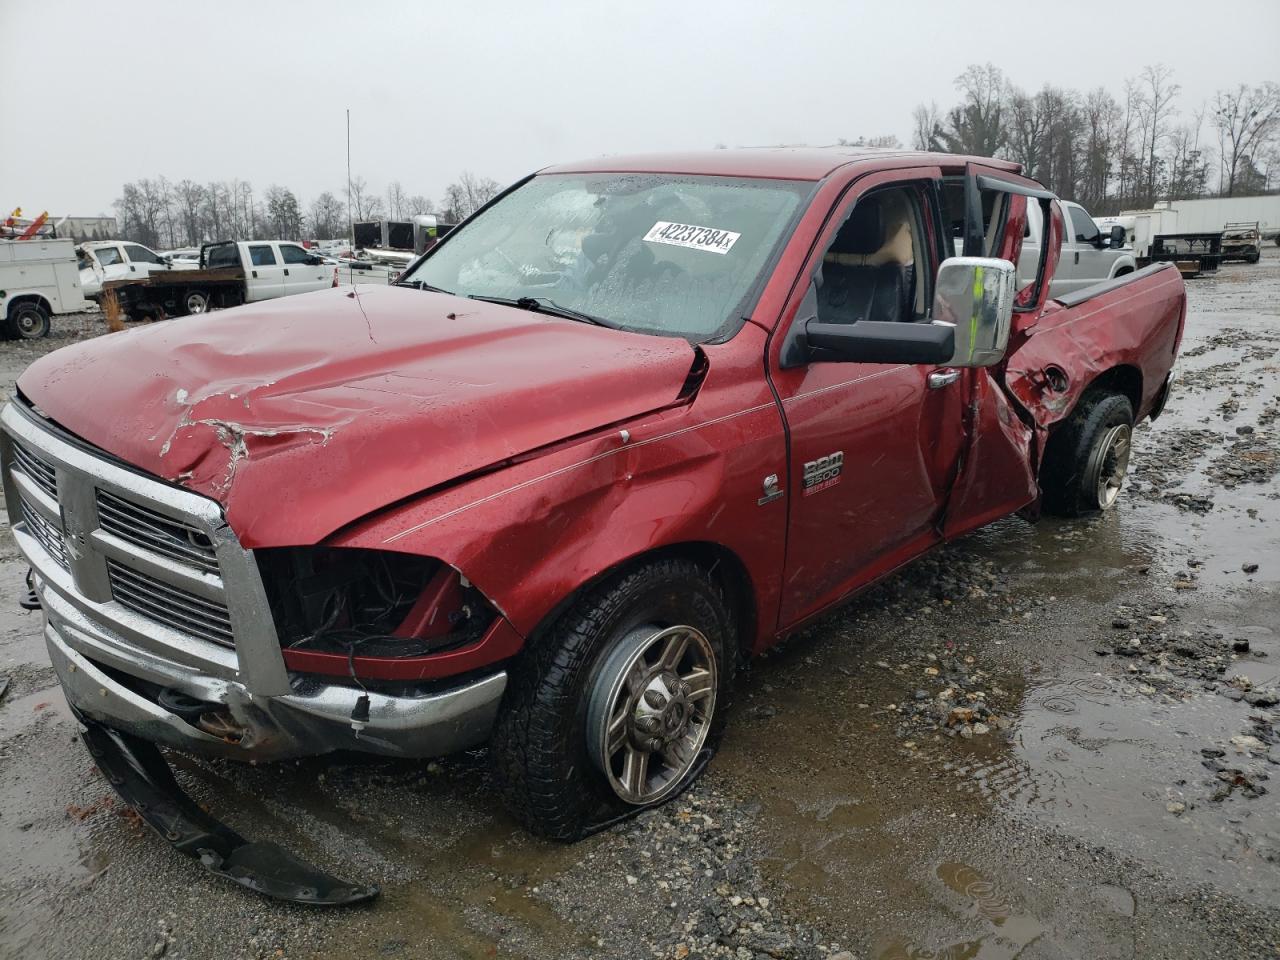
329, 333, 787, 655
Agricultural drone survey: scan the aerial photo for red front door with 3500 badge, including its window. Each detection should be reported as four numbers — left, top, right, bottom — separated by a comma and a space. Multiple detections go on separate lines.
769, 168, 964, 627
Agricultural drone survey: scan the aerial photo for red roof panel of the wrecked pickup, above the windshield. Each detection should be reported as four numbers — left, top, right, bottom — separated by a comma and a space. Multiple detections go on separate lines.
540, 147, 1021, 180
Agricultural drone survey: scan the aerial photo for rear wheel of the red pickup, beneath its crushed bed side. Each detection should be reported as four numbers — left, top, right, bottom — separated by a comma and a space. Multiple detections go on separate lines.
1041, 393, 1134, 517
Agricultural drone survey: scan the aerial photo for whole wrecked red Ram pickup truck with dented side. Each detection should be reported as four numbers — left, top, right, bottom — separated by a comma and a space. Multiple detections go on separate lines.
0, 150, 1185, 901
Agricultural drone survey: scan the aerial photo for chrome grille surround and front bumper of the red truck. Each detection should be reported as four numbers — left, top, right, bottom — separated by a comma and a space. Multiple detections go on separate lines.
0, 406, 507, 760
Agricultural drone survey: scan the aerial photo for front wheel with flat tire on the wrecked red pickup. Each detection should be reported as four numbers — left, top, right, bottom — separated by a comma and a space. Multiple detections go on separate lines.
493, 558, 737, 841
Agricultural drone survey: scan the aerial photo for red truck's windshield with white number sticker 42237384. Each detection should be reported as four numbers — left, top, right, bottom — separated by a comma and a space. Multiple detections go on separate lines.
401, 173, 813, 340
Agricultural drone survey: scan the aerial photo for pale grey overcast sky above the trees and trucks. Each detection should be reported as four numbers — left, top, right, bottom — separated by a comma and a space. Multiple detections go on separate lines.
0, 0, 1280, 216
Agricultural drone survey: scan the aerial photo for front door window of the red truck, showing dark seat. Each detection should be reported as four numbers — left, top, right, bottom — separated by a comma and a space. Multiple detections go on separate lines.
815, 187, 933, 324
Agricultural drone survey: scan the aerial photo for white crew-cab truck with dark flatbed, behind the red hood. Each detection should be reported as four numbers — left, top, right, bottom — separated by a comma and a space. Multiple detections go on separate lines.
104, 241, 337, 320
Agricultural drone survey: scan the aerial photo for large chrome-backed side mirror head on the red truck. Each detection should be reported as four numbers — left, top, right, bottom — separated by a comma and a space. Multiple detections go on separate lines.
933, 257, 1018, 366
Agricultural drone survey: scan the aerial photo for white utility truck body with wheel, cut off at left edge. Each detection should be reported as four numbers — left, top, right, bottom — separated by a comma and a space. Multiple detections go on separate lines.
0, 238, 90, 340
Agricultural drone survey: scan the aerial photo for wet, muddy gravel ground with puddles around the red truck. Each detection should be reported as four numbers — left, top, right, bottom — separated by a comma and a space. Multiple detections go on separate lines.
0, 248, 1280, 960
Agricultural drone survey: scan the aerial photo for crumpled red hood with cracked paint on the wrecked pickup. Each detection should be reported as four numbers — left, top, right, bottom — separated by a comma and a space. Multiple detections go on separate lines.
18, 287, 694, 547
